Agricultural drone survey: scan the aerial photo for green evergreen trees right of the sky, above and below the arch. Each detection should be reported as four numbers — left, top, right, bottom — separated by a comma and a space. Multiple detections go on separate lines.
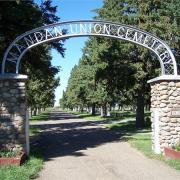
62, 0, 180, 128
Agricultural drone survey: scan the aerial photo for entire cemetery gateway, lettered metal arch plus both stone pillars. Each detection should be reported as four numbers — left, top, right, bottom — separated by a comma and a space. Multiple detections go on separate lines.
0, 20, 180, 154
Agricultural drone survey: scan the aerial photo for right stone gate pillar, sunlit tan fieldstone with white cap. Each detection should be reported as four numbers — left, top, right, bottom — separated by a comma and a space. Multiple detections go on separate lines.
148, 76, 180, 153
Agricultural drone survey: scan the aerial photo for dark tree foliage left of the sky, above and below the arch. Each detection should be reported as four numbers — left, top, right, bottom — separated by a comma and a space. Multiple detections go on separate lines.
0, 0, 64, 112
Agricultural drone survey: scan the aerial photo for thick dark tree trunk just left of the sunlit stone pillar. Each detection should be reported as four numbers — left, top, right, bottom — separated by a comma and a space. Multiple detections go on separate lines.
136, 90, 144, 128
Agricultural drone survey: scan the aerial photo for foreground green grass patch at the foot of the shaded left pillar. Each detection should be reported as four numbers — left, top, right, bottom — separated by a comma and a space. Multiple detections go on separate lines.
0, 148, 43, 180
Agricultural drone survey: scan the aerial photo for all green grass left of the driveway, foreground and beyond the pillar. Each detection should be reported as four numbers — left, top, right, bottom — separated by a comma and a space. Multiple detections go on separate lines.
0, 109, 51, 180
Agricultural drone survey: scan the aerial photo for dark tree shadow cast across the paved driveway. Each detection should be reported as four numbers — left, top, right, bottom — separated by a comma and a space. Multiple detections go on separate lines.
31, 112, 150, 161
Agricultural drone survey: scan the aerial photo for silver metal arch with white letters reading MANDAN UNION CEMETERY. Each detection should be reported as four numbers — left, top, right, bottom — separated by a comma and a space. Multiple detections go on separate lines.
2, 20, 177, 75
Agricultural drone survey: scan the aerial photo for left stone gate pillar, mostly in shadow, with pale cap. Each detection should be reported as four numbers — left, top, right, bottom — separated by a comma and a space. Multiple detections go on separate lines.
0, 74, 28, 152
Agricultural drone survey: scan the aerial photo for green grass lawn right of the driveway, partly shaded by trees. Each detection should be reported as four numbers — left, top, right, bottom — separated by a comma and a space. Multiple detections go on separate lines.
64, 111, 180, 170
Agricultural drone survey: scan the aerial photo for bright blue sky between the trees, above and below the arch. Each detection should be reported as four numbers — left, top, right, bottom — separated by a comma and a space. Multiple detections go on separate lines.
41, 0, 103, 105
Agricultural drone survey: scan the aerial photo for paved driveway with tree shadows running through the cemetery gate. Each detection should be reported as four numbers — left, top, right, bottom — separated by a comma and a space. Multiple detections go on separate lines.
29, 111, 180, 180
